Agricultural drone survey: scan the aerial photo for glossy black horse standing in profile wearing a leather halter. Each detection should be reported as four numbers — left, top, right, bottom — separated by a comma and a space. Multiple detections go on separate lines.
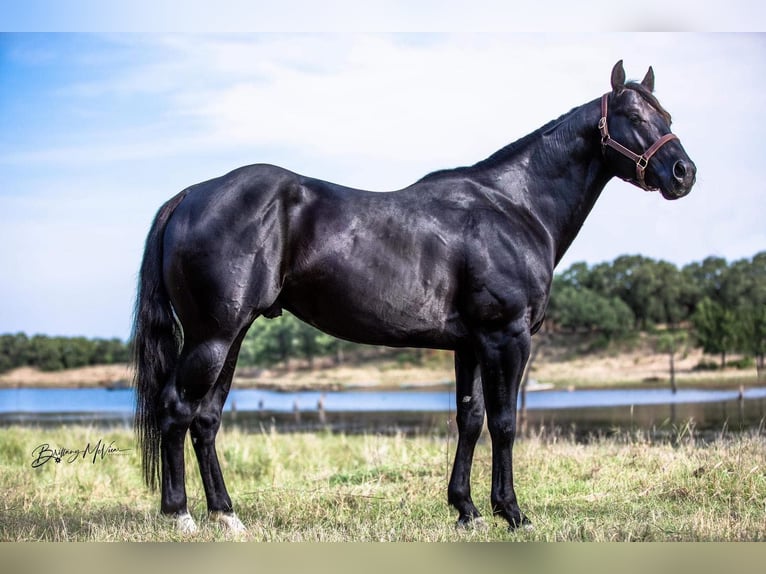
134, 61, 696, 531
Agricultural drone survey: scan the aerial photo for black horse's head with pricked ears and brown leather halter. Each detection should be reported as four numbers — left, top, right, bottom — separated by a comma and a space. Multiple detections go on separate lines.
599, 60, 697, 199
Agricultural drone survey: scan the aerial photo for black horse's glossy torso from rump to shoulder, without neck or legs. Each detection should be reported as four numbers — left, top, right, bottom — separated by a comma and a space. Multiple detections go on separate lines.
165, 165, 556, 348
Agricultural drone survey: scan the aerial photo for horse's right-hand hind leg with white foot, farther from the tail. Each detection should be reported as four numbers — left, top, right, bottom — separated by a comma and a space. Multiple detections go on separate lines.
190, 328, 247, 534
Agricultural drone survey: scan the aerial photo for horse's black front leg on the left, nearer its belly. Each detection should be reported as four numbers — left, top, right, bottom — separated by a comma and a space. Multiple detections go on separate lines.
447, 349, 484, 527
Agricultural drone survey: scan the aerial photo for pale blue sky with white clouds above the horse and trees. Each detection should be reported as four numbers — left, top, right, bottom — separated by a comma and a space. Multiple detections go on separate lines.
0, 22, 766, 339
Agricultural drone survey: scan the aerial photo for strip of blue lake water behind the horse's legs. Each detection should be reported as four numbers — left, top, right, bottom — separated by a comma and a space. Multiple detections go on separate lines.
0, 387, 766, 431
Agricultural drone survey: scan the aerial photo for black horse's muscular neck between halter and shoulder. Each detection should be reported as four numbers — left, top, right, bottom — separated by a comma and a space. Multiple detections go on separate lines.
475, 100, 611, 265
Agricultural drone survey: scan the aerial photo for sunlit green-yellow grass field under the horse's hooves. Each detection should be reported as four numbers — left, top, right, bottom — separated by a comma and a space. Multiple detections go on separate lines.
0, 426, 766, 541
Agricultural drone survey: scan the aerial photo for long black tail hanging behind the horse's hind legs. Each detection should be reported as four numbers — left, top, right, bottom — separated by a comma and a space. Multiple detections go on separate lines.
132, 192, 186, 490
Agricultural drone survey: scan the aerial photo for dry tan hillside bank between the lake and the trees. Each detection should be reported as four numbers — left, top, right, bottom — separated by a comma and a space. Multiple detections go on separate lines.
0, 335, 755, 390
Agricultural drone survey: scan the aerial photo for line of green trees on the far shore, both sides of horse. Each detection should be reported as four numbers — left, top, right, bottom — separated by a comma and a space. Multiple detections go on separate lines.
0, 251, 766, 378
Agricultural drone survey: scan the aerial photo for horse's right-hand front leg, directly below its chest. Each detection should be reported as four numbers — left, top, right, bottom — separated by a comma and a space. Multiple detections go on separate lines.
478, 325, 531, 529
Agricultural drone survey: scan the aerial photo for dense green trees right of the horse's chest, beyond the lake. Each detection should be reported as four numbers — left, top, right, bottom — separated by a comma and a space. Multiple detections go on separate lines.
548, 252, 766, 372
